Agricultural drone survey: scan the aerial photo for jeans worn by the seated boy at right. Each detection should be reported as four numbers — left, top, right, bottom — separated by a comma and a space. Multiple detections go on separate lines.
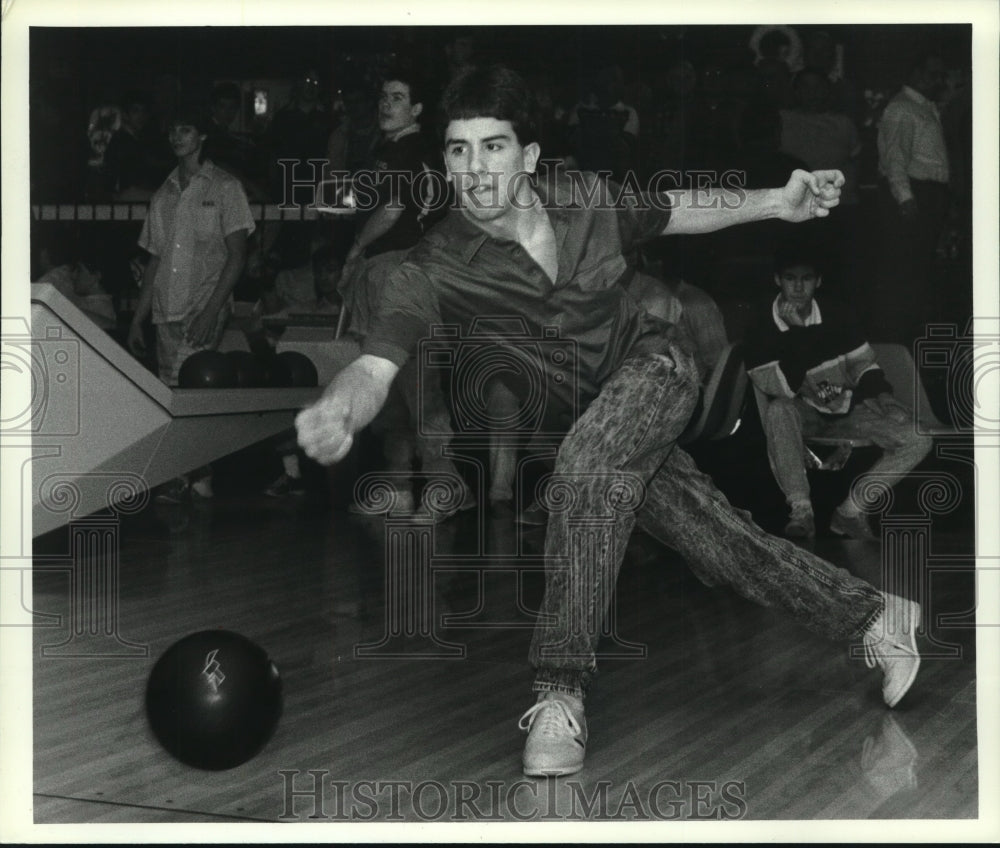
763, 397, 933, 506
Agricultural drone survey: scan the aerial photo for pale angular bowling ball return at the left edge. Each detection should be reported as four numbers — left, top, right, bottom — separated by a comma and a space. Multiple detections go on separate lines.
22, 283, 320, 536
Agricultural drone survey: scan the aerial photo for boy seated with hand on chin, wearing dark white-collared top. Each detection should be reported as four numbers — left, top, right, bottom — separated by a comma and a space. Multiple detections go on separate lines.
744, 243, 931, 540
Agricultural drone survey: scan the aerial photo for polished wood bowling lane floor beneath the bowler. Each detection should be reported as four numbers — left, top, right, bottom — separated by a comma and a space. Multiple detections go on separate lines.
34, 430, 981, 822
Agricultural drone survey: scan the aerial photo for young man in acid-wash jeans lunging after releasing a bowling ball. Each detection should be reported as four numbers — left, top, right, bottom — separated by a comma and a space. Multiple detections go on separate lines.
296, 67, 920, 775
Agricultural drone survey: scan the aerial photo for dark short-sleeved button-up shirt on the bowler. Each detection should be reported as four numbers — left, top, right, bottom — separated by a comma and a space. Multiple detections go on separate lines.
362, 174, 689, 414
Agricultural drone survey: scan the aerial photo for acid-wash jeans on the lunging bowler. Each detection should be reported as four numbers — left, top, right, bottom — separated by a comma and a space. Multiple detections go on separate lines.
529, 345, 883, 697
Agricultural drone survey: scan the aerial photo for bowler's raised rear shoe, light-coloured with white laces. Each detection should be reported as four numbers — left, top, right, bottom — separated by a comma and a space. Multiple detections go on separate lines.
864, 592, 920, 707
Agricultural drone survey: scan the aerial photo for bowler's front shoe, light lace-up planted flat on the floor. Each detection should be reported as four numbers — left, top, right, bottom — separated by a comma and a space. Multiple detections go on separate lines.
517, 692, 587, 777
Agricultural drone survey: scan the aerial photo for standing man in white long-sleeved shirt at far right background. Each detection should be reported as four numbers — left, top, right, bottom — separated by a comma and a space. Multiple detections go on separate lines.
876, 53, 949, 342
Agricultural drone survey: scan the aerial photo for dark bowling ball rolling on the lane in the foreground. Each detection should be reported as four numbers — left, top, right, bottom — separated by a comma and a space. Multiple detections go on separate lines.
146, 630, 282, 771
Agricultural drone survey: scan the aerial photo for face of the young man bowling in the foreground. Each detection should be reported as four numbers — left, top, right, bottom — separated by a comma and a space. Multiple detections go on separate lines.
444, 118, 540, 229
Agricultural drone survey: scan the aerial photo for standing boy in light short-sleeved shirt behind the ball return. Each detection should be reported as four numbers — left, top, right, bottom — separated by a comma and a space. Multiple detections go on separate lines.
128, 106, 254, 501
